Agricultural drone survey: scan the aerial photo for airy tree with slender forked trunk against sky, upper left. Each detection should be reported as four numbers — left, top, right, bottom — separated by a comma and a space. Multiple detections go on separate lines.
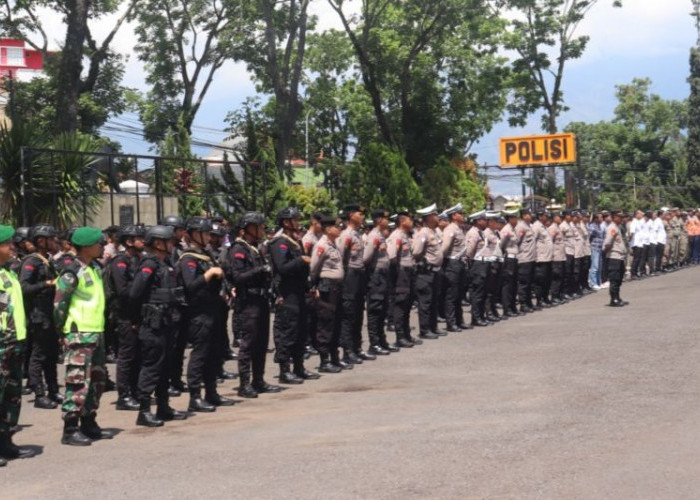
135, 0, 249, 143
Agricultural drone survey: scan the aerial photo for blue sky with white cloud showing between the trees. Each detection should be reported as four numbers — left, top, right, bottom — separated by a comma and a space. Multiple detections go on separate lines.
58, 0, 697, 194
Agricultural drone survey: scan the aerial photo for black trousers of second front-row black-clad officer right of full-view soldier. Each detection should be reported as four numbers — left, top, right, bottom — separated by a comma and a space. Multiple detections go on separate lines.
187, 307, 221, 393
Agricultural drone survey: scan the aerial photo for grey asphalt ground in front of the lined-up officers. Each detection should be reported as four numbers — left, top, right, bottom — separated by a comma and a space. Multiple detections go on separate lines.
0, 267, 700, 499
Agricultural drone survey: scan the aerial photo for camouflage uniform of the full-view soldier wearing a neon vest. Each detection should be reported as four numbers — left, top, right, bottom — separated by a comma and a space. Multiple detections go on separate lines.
54, 259, 106, 419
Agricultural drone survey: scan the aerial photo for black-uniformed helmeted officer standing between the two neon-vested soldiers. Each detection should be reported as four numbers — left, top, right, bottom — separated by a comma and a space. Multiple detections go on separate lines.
19, 225, 63, 409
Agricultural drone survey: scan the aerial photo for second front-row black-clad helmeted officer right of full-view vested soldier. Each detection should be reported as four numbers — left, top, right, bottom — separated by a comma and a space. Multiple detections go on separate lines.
178, 217, 233, 412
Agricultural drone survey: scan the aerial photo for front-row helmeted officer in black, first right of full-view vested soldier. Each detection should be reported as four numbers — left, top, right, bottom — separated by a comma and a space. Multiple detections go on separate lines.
128, 226, 187, 427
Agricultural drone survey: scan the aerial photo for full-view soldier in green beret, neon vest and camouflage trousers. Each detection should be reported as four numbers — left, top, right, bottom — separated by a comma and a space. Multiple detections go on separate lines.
54, 227, 112, 446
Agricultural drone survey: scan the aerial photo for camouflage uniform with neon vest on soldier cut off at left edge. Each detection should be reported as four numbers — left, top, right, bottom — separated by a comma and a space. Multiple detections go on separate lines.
0, 269, 26, 434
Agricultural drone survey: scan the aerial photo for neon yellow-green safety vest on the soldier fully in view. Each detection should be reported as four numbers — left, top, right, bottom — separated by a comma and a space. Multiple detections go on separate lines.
63, 266, 105, 333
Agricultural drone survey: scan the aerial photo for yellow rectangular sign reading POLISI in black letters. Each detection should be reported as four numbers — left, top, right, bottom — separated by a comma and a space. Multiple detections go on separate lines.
501, 134, 576, 168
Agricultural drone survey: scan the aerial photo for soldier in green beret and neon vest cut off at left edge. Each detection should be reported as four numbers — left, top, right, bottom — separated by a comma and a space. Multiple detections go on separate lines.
0, 225, 33, 467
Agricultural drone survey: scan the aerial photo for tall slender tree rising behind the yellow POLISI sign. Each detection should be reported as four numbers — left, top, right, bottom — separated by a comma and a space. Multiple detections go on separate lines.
505, 0, 622, 199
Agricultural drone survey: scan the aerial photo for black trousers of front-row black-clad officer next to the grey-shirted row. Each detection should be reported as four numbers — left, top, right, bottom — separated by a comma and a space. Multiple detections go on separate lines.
273, 288, 306, 364
